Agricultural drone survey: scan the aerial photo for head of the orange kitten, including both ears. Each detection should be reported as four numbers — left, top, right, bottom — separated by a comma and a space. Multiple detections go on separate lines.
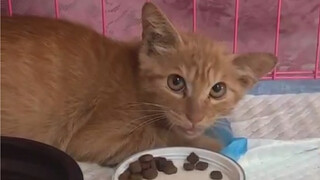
139, 3, 277, 138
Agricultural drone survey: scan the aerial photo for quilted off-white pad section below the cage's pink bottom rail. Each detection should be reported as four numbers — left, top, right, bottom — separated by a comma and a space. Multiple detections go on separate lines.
230, 93, 320, 140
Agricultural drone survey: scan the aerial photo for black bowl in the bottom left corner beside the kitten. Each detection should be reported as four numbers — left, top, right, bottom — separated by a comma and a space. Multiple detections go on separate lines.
1, 136, 83, 180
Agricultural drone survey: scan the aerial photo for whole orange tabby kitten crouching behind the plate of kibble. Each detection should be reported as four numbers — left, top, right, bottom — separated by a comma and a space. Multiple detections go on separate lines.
1, 3, 277, 165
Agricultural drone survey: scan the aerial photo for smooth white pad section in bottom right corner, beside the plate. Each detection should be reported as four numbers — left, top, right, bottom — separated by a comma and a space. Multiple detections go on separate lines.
239, 138, 320, 180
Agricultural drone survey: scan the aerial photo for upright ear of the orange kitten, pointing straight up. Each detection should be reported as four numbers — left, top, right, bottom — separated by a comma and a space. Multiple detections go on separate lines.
141, 3, 182, 56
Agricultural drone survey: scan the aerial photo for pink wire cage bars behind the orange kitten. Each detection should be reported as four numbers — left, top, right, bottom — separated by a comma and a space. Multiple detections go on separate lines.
7, 0, 320, 80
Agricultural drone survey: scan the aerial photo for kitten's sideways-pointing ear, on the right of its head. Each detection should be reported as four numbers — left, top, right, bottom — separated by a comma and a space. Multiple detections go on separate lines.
233, 53, 278, 88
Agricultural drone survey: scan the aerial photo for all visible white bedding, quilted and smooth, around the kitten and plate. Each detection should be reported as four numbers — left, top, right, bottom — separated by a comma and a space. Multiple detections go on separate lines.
80, 93, 320, 180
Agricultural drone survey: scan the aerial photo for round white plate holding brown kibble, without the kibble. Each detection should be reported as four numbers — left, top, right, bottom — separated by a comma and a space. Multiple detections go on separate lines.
112, 147, 245, 180
